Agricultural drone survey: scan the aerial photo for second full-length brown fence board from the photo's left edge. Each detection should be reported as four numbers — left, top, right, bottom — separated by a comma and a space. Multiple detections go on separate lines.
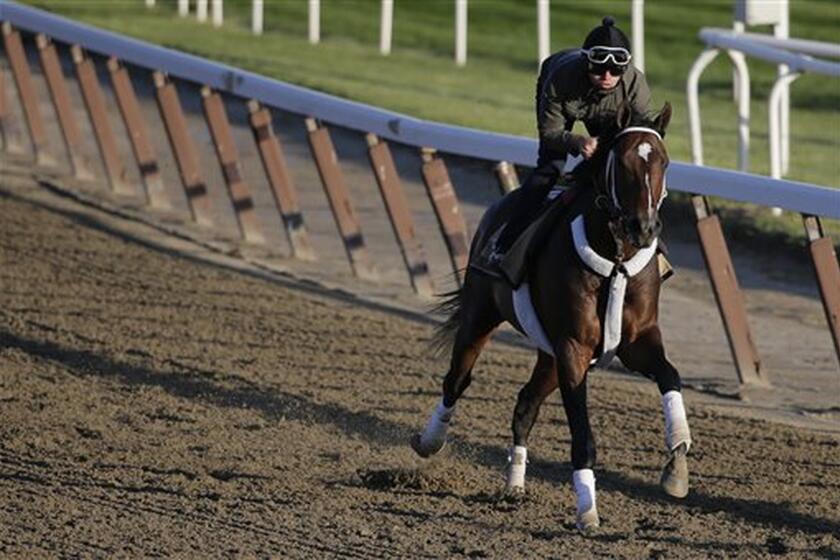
36, 34, 92, 179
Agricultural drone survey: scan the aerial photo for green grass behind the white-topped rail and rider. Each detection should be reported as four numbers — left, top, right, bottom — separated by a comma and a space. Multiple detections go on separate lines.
11, 0, 840, 244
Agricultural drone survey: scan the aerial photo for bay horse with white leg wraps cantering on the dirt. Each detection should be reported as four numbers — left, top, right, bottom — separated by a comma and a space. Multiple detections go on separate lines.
411, 103, 691, 532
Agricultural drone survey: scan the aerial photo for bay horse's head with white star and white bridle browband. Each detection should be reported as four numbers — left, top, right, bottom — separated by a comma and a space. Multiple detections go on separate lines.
598, 103, 671, 248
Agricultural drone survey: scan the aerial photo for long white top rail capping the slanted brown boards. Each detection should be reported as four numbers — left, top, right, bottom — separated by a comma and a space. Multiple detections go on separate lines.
0, 0, 840, 219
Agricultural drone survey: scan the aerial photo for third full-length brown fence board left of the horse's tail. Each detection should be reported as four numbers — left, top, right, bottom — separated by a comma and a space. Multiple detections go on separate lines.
306, 119, 378, 280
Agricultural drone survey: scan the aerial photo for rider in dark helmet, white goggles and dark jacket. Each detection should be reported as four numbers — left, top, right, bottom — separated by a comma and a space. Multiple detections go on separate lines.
494, 16, 664, 280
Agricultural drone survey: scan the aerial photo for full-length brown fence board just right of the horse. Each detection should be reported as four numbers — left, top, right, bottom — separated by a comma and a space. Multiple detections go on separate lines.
697, 214, 767, 385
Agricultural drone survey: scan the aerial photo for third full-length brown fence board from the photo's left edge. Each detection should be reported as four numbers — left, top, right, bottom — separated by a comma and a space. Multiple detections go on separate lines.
71, 45, 132, 195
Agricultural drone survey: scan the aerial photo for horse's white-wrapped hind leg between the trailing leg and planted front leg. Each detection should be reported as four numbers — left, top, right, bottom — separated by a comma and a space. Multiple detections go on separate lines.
506, 352, 557, 493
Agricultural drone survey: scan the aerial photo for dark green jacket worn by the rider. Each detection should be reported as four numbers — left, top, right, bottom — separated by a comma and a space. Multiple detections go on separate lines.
536, 49, 651, 166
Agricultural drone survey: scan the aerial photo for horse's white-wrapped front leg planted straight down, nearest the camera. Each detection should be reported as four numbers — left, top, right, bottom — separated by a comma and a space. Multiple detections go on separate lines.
555, 341, 600, 532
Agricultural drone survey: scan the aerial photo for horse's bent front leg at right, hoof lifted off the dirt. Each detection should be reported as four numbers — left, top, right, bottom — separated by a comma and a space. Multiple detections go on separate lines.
618, 326, 691, 498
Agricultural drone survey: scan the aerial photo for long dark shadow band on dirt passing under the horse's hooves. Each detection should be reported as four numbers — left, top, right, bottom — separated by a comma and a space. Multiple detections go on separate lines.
0, 328, 840, 544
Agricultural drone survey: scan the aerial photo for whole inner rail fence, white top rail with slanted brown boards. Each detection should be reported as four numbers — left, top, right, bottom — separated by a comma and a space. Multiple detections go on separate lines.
0, 1, 840, 384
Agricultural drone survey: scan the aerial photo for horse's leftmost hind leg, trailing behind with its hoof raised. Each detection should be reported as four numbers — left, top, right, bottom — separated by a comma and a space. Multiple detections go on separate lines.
411, 282, 502, 457
